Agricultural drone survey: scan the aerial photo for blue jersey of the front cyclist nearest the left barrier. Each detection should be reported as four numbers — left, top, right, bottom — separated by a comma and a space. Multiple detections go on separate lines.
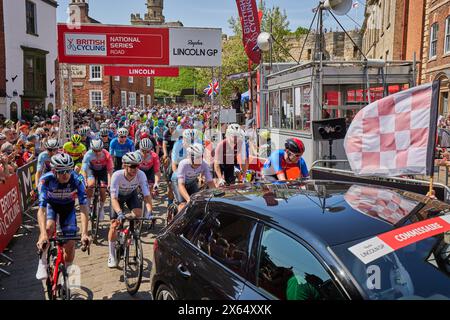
39, 171, 87, 208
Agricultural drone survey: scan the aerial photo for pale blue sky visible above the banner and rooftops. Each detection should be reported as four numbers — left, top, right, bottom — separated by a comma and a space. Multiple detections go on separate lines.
58, 0, 365, 35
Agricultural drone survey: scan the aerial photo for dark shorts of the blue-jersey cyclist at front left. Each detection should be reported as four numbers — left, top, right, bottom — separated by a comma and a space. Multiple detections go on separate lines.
47, 202, 78, 237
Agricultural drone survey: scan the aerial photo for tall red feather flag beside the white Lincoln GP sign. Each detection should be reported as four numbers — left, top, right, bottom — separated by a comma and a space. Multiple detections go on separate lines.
236, 0, 261, 64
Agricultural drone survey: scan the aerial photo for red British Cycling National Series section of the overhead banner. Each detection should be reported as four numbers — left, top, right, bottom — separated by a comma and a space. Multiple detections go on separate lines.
58, 24, 169, 65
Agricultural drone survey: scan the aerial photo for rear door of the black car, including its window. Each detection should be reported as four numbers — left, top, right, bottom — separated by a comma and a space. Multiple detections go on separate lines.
178, 203, 257, 300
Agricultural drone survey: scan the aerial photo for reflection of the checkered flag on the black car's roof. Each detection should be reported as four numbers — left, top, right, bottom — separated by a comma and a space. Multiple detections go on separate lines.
344, 185, 419, 225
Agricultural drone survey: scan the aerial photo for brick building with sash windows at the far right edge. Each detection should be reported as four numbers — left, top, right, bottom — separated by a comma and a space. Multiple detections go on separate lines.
422, 0, 450, 115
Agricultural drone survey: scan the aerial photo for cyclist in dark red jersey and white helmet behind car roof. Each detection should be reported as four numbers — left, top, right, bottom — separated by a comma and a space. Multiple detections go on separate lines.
214, 123, 249, 185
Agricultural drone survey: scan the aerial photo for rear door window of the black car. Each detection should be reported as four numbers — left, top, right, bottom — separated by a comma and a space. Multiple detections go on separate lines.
196, 211, 256, 276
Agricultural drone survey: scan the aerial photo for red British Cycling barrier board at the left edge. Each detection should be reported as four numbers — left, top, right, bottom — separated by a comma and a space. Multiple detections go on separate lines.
0, 175, 22, 253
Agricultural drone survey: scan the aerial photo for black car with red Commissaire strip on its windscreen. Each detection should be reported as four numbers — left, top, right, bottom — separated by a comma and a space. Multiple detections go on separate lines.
151, 181, 450, 300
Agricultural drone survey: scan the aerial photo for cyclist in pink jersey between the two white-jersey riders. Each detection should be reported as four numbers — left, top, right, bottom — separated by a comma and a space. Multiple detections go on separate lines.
137, 139, 161, 214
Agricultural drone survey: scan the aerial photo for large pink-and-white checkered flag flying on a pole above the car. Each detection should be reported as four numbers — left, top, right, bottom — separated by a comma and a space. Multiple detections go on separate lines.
344, 81, 440, 176
